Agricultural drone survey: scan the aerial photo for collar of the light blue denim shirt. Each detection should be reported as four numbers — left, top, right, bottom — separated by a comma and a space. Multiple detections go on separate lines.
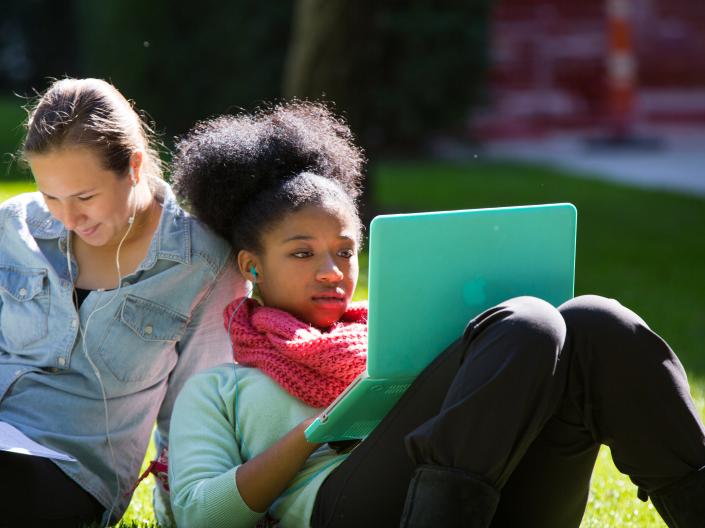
27, 180, 191, 270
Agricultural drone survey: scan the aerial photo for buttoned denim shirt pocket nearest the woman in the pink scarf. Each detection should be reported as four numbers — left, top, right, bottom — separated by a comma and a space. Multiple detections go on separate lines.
100, 295, 188, 382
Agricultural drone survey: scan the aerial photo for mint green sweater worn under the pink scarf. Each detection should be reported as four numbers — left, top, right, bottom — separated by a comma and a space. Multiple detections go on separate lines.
169, 364, 345, 528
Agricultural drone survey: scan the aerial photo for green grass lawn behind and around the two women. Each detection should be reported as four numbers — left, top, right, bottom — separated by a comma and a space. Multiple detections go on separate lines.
0, 162, 705, 528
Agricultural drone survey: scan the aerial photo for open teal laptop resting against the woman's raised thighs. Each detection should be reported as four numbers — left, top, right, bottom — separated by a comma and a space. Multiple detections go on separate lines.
305, 204, 577, 442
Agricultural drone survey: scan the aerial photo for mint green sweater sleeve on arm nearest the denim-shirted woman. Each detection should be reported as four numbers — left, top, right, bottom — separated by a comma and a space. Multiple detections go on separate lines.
169, 367, 263, 528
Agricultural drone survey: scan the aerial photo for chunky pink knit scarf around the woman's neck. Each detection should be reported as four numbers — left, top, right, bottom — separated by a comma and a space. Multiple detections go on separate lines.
223, 298, 367, 407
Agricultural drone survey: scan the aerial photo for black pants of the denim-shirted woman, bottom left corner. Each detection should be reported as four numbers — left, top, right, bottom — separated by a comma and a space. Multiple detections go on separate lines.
0, 451, 105, 528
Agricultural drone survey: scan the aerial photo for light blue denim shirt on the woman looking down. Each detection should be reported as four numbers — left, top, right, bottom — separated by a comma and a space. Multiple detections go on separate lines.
0, 182, 244, 519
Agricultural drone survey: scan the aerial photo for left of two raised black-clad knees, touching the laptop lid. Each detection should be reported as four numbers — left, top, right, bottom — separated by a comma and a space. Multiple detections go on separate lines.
500, 296, 566, 369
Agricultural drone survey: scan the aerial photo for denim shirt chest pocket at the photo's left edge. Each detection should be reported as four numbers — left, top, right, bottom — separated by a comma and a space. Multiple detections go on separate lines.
0, 265, 51, 353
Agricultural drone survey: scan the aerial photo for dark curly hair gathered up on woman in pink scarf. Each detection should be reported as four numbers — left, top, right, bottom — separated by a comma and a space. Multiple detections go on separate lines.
172, 102, 365, 254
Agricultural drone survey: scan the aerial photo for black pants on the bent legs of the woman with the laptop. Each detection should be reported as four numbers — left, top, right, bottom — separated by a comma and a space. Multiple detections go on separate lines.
311, 296, 705, 528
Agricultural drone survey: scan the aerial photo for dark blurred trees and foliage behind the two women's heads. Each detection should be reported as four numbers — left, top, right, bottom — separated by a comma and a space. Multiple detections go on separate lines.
0, 0, 490, 156
